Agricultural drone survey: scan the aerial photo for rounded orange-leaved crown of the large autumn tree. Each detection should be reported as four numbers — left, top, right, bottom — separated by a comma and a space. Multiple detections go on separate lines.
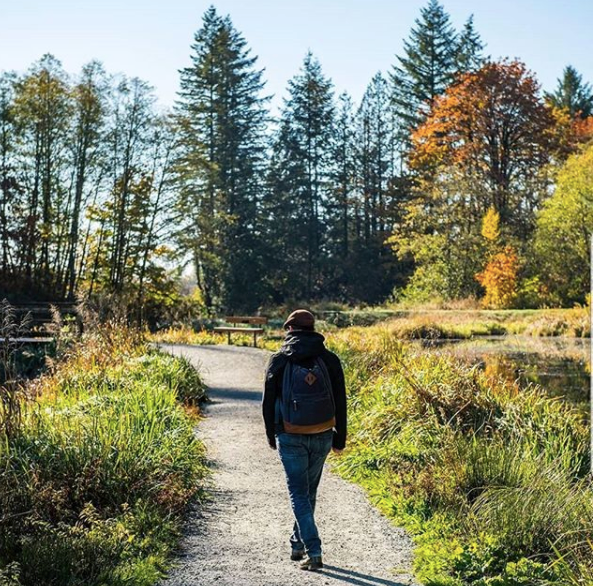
410, 60, 556, 237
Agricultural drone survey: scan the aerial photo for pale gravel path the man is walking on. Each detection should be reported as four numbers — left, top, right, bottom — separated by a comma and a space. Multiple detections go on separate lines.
162, 345, 413, 586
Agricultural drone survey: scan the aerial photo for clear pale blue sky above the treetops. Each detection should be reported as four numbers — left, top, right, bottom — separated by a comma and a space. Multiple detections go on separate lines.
0, 0, 593, 111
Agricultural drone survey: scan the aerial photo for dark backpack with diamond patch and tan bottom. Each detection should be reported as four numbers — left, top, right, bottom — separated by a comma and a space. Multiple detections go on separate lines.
280, 358, 336, 433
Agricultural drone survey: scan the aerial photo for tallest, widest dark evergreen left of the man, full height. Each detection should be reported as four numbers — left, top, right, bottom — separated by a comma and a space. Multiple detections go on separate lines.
177, 7, 267, 309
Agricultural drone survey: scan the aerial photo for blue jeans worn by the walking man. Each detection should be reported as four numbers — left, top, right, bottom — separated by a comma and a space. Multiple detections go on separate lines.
276, 429, 333, 556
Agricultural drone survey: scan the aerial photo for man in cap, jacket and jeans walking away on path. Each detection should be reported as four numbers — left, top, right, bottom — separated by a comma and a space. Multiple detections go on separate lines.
262, 309, 346, 570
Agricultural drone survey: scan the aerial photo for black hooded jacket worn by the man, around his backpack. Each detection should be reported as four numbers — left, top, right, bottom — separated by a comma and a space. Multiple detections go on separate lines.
262, 330, 346, 450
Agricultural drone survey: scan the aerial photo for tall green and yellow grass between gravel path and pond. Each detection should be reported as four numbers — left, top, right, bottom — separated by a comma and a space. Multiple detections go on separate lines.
330, 328, 593, 586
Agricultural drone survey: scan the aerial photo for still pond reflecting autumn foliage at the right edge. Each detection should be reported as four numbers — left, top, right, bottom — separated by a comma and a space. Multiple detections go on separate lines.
412, 335, 590, 407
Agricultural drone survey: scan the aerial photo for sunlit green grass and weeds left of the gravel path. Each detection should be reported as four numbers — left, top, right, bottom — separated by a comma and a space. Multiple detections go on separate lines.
0, 328, 207, 586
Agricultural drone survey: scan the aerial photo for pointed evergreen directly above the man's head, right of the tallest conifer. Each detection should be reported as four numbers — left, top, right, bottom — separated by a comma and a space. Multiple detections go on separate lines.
268, 52, 334, 300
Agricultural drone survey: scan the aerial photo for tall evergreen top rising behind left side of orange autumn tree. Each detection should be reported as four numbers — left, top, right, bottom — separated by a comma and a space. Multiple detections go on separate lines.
391, 0, 458, 134
